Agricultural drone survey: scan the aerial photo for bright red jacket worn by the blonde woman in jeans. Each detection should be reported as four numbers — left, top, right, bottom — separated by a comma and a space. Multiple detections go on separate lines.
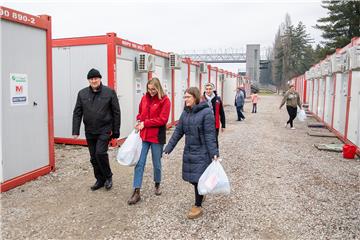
136, 93, 170, 144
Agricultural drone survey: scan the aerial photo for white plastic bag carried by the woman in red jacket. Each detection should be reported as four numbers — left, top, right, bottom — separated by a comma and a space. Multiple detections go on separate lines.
116, 130, 142, 166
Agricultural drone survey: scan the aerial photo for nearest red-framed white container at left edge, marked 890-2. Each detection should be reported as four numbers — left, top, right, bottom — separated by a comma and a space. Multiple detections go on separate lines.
0, 6, 55, 192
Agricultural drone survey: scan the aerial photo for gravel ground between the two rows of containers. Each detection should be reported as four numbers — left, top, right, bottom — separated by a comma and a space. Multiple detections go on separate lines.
1, 96, 360, 239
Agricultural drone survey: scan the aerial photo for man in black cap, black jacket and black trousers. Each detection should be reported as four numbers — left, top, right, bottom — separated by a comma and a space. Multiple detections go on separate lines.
72, 68, 121, 191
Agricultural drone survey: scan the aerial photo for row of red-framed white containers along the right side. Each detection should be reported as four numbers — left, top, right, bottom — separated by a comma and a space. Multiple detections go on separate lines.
293, 37, 360, 152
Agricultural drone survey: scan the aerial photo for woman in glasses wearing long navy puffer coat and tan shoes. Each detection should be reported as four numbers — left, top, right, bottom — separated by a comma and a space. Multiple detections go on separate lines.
164, 87, 219, 219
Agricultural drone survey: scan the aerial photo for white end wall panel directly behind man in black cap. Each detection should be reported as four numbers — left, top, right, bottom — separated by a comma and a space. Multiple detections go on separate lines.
53, 44, 108, 139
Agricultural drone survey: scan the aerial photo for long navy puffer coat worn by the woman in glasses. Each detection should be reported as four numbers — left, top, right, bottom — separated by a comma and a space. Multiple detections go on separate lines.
164, 102, 219, 183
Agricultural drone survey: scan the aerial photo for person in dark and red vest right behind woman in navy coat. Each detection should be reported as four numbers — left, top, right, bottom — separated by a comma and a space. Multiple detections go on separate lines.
203, 83, 225, 148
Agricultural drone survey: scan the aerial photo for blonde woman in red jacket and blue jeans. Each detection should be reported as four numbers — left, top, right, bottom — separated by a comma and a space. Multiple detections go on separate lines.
128, 78, 170, 204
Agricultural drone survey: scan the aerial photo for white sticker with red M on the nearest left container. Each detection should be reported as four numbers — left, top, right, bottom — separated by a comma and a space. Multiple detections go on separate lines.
10, 73, 29, 106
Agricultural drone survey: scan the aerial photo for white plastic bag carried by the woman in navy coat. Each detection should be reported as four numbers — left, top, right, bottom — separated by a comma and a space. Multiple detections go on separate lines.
198, 159, 230, 195
